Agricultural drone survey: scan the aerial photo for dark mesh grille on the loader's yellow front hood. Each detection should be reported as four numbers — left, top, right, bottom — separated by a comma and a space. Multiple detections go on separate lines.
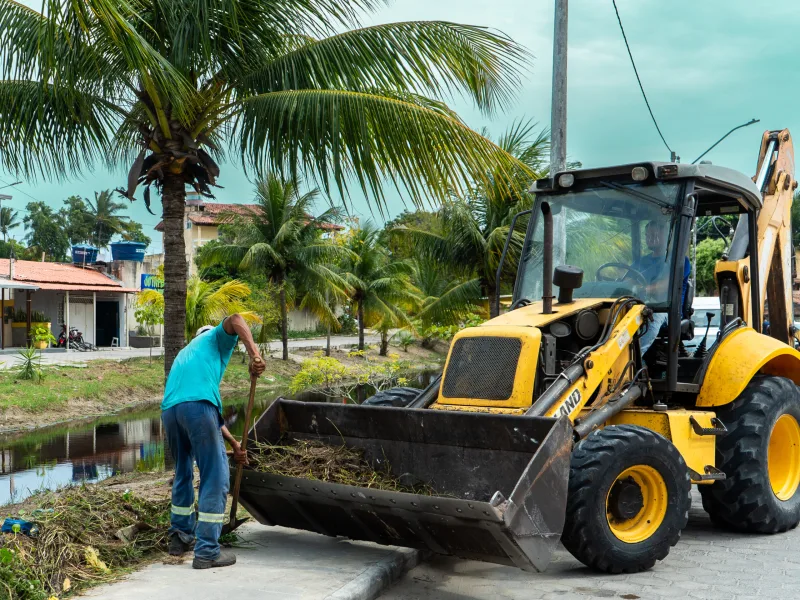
442, 336, 522, 400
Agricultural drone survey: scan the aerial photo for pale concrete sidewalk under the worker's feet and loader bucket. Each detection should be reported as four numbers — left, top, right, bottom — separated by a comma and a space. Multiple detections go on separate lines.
84, 523, 415, 600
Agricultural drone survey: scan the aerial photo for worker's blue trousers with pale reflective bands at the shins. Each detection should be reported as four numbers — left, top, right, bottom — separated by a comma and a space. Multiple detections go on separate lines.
161, 400, 230, 560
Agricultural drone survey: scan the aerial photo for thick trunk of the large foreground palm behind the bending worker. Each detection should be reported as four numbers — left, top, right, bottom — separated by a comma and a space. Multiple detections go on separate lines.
161, 173, 187, 377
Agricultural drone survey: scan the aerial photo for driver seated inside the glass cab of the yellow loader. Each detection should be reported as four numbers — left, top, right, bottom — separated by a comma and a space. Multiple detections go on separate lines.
631, 220, 692, 356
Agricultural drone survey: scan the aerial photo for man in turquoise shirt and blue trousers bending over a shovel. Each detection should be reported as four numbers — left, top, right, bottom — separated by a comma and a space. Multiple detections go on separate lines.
161, 314, 265, 569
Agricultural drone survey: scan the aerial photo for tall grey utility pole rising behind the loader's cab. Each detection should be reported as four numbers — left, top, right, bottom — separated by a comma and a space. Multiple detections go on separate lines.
550, 0, 568, 265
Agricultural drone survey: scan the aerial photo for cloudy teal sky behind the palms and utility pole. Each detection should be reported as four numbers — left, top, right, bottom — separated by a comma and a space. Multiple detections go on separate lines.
6, 0, 800, 252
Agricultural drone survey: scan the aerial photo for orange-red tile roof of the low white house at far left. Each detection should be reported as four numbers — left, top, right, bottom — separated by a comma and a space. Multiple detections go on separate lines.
0, 258, 138, 292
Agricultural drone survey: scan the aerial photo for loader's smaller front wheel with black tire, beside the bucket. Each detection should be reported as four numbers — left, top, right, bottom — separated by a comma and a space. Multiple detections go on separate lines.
561, 425, 691, 573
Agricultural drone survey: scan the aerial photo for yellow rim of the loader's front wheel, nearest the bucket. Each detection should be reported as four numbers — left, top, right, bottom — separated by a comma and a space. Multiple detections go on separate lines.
606, 464, 668, 544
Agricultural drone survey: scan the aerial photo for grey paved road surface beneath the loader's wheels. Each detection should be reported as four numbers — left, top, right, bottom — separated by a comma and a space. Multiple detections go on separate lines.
380, 491, 800, 600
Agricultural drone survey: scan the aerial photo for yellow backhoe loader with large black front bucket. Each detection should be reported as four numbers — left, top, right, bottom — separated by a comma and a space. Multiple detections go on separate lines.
241, 130, 800, 573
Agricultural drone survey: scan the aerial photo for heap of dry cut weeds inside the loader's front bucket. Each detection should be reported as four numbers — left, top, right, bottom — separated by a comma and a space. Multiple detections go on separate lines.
249, 440, 441, 496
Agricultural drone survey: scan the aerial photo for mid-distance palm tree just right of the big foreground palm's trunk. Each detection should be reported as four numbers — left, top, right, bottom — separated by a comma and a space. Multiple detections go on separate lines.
201, 173, 347, 360
